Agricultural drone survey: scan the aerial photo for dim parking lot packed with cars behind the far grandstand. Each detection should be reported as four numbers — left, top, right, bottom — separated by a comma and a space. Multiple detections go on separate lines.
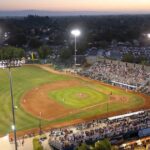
86, 45, 150, 64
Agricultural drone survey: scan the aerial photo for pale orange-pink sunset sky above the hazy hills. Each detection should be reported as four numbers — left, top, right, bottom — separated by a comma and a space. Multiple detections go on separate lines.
0, 0, 150, 11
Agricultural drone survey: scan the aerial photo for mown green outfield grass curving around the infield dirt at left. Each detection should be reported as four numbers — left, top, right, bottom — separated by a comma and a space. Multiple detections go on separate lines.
0, 66, 69, 134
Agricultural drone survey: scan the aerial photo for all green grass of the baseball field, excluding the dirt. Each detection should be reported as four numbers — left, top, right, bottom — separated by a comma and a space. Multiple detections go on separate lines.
0, 66, 143, 135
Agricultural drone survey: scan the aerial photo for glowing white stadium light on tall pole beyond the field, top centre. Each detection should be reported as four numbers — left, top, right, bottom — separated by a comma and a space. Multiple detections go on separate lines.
71, 29, 81, 69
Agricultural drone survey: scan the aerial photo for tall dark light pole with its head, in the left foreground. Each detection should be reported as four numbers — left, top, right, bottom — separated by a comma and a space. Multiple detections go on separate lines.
0, 60, 22, 150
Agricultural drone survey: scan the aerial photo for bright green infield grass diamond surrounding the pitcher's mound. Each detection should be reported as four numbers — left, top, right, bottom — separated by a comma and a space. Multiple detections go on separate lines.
49, 85, 108, 108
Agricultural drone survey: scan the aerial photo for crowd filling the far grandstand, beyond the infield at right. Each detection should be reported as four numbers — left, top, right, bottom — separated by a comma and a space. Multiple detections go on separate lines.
79, 61, 150, 92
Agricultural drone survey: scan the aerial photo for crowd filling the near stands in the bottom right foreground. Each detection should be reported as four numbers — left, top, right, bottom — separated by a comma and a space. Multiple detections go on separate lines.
49, 110, 150, 150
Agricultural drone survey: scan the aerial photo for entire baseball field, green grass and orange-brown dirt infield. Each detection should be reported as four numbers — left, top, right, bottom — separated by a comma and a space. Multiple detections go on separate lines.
0, 65, 150, 135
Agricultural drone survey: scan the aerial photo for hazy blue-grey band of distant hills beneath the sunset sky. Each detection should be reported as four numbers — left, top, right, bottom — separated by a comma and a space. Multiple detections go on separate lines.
0, 10, 150, 17
